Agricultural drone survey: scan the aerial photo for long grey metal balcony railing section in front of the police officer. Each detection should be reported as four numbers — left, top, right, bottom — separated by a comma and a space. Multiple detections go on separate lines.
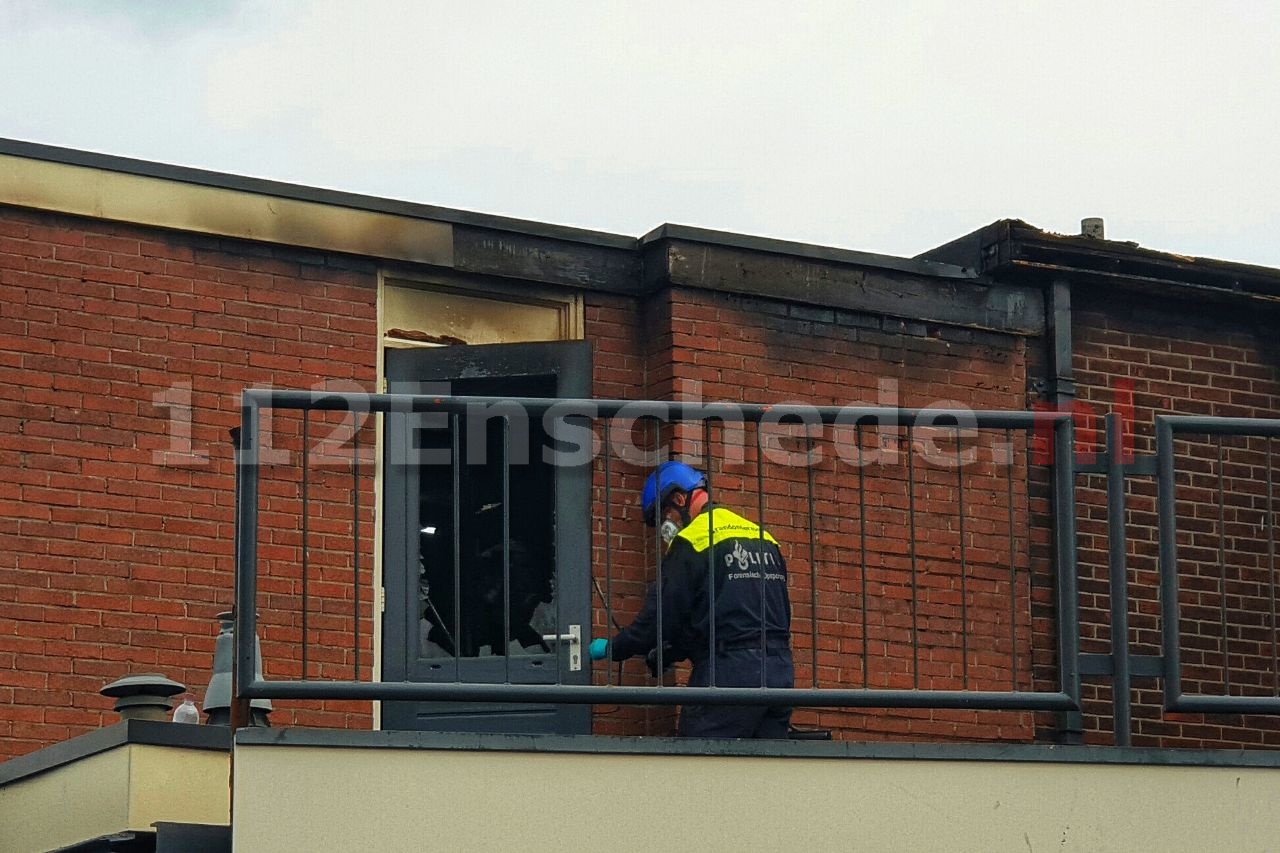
236, 389, 1079, 711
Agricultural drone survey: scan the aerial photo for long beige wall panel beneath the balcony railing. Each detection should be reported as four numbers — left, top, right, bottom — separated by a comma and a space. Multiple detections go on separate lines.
234, 745, 1280, 853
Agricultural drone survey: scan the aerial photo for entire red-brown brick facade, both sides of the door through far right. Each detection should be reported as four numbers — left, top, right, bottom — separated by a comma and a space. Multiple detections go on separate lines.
12, 197, 1280, 756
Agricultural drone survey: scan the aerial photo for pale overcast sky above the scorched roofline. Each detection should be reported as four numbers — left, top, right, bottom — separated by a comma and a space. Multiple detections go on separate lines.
0, 0, 1280, 266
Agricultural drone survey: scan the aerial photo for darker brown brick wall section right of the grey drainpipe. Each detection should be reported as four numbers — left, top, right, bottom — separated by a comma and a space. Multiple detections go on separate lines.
1073, 288, 1280, 748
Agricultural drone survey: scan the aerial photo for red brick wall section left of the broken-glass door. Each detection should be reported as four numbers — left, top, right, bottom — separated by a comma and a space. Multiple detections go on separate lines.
0, 209, 376, 756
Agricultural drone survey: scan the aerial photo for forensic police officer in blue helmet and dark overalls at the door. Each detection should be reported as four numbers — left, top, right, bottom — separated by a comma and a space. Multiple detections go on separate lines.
589, 461, 795, 738
